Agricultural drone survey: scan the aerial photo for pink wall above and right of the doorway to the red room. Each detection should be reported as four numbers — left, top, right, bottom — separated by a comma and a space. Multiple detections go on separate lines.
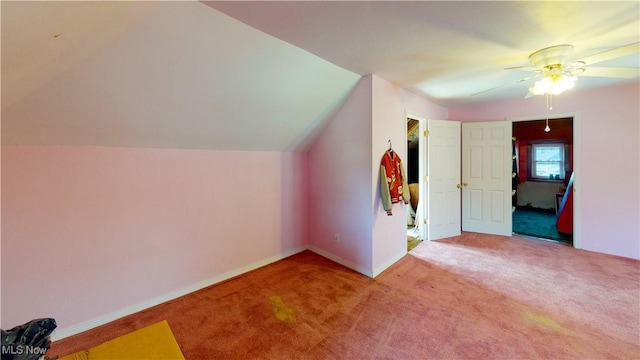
449, 82, 640, 259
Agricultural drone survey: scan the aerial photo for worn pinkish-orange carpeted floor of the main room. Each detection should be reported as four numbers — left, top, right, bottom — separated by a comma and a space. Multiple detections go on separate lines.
48, 233, 640, 360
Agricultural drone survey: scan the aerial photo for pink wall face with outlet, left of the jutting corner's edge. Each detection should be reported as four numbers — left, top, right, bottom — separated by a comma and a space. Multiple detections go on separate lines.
308, 76, 372, 275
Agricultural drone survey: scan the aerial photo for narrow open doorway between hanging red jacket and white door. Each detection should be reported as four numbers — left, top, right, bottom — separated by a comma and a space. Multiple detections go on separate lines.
406, 118, 424, 251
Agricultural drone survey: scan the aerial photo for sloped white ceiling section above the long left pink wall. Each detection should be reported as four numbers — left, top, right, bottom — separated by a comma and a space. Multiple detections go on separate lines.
2, 1, 360, 151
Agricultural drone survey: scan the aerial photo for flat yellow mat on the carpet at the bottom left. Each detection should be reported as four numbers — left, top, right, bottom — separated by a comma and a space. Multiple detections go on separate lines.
60, 320, 184, 360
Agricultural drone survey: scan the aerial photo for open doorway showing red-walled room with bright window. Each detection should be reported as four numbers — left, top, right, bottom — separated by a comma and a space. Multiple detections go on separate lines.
512, 117, 574, 246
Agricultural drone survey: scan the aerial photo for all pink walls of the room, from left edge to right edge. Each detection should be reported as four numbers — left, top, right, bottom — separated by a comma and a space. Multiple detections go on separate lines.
1, 80, 640, 338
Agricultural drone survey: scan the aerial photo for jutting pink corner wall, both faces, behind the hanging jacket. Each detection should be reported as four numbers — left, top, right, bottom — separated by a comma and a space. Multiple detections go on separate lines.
309, 75, 447, 277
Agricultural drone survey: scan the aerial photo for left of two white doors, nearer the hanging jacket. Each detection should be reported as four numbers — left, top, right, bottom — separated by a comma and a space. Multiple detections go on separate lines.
427, 120, 461, 240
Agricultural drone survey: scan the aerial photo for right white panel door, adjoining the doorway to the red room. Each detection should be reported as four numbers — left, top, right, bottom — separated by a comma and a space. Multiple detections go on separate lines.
462, 121, 512, 236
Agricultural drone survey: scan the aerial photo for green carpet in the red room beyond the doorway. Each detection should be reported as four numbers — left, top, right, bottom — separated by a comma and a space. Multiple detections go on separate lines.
513, 207, 573, 245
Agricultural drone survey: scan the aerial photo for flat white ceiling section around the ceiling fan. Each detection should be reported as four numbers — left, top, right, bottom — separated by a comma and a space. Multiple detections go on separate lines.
206, 1, 640, 107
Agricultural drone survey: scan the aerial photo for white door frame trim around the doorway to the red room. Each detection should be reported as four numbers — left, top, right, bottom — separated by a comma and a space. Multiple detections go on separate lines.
506, 112, 582, 249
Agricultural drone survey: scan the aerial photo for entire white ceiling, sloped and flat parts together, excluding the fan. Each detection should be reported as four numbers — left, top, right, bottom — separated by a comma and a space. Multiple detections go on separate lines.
1, 1, 640, 151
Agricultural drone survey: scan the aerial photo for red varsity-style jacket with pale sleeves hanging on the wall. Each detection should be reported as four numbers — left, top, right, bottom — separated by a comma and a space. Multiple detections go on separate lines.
380, 149, 410, 215
